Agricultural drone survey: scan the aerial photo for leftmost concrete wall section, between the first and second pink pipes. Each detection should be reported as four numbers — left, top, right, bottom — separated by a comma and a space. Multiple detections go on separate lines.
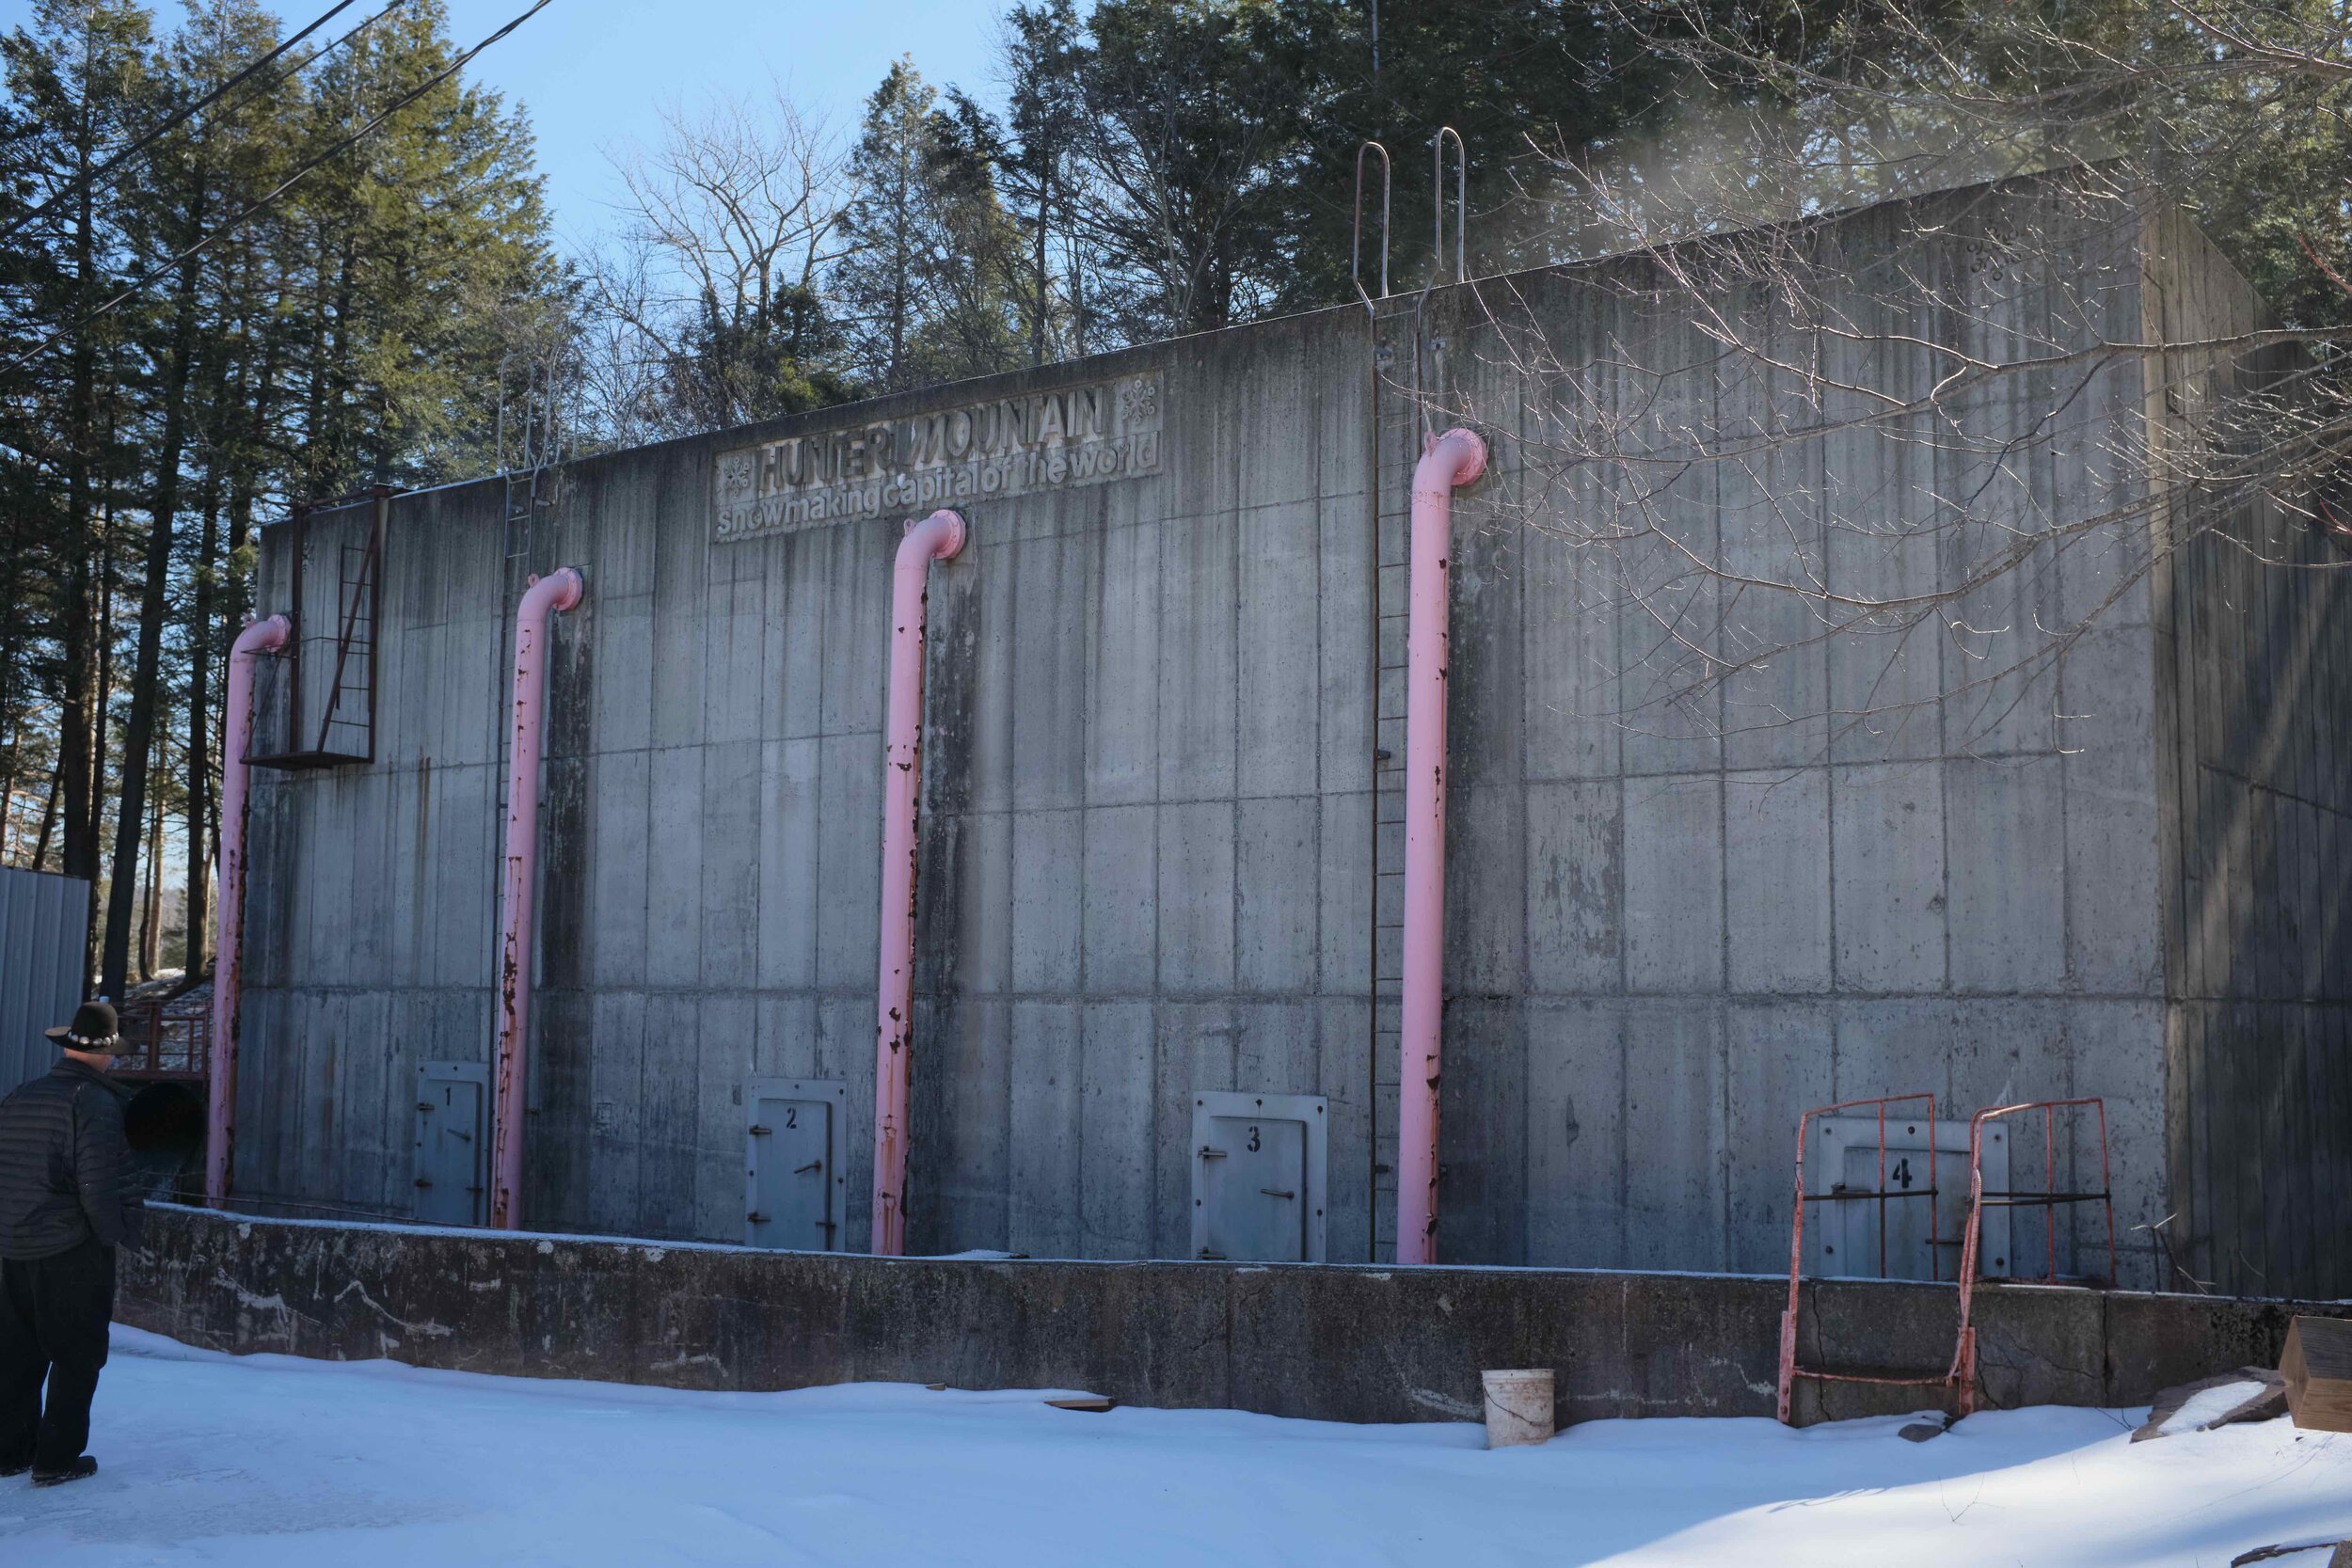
238, 484, 513, 1213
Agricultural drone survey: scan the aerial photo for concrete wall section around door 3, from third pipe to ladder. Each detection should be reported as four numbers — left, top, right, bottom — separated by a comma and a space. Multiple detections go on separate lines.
903, 312, 1374, 1260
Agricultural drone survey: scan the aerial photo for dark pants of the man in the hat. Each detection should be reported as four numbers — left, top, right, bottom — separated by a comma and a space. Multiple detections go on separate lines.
0, 1237, 116, 1474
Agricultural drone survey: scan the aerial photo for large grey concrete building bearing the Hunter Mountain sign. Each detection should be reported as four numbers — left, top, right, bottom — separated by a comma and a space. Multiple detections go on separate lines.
235, 171, 2352, 1293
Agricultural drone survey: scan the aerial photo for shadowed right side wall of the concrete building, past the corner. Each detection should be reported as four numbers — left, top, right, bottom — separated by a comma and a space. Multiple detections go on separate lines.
2143, 214, 2352, 1293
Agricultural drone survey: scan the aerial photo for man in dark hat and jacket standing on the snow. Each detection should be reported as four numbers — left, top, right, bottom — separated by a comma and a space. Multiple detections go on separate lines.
0, 1002, 141, 1486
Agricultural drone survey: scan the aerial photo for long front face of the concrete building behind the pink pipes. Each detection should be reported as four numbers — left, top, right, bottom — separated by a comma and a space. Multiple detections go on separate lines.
238, 171, 2324, 1279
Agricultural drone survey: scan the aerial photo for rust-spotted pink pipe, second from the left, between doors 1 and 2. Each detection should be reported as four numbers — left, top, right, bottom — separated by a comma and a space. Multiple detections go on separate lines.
489, 566, 586, 1229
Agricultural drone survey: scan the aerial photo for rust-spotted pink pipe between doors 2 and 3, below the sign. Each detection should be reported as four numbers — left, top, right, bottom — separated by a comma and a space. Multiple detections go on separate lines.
873, 508, 964, 1258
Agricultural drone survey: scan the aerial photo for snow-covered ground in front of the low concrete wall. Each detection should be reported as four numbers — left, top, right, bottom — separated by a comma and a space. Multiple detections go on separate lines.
0, 1328, 2352, 1568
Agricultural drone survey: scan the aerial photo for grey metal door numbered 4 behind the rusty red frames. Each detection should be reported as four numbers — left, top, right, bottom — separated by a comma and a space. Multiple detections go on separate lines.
1806, 1117, 2009, 1279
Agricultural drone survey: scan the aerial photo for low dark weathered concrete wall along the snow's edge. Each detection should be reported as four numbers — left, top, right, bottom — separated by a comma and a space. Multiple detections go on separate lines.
118, 1209, 2345, 1422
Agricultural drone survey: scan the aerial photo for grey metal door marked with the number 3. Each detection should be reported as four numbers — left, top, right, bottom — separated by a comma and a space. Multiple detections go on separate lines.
1193, 1093, 1327, 1262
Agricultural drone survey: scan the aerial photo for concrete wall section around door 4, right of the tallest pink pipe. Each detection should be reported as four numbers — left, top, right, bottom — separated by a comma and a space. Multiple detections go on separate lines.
1381, 177, 2167, 1281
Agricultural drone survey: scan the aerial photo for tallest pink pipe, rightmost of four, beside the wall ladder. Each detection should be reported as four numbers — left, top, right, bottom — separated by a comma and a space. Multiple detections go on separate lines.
1397, 428, 1486, 1262
